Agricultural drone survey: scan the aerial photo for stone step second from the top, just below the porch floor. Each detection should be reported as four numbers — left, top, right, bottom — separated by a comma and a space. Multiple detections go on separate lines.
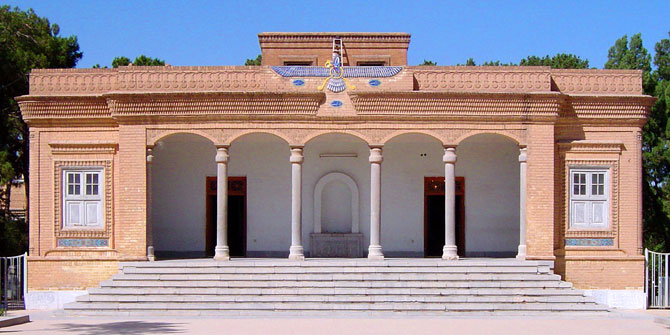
122, 266, 550, 274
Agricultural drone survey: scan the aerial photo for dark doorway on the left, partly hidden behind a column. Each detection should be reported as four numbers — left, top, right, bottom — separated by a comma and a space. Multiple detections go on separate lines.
205, 177, 247, 257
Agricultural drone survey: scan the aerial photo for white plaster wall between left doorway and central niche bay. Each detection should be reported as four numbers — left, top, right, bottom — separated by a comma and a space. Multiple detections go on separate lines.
228, 133, 291, 256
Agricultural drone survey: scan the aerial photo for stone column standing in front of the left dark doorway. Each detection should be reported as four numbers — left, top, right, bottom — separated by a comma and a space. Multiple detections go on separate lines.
214, 147, 230, 261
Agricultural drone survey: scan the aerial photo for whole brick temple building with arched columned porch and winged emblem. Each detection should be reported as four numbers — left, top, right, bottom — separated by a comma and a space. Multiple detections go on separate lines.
17, 33, 654, 305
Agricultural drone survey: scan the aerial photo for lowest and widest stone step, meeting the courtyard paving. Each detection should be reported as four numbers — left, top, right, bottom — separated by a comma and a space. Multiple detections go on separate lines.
66, 302, 607, 311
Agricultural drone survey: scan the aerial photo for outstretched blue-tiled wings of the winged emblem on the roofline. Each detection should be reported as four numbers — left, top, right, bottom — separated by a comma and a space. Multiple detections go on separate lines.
272, 66, 402, 78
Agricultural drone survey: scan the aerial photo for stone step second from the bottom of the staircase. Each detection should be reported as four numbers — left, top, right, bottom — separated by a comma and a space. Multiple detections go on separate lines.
77, 294, 594, 303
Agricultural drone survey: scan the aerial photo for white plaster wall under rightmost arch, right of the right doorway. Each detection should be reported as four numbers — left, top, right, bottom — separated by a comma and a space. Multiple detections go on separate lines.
456, 134, 519, 255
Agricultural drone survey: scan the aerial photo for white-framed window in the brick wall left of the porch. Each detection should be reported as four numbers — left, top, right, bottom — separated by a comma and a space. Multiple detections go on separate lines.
63, 169, 103, 228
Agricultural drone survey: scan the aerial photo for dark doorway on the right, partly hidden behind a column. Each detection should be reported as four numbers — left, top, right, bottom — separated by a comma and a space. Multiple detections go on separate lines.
423, 177, 465, 257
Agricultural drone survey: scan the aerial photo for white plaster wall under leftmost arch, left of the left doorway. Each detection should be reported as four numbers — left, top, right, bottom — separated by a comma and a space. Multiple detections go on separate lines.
152, 134, 216, 253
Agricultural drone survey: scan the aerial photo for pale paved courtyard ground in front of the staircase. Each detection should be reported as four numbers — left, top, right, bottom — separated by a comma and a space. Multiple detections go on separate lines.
0, 311, 670, 335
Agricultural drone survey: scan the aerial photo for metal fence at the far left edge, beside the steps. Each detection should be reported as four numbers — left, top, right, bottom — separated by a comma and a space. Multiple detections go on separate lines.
0, 254, 28, 310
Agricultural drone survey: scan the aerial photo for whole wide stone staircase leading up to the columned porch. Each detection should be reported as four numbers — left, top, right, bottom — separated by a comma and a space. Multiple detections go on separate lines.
64, 259, 607, 316
